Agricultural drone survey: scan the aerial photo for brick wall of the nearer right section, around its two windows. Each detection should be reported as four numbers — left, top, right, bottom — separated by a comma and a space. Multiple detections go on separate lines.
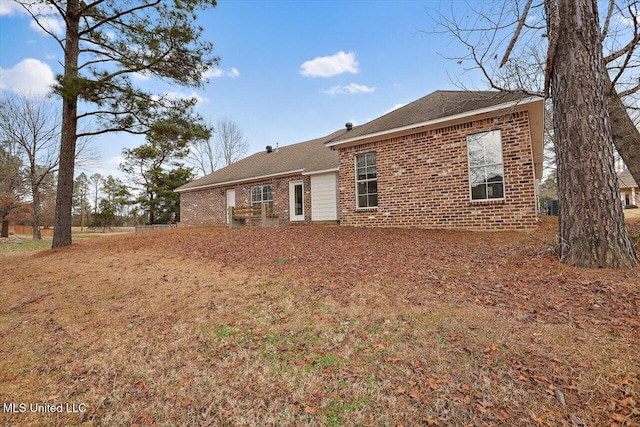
340, 111, 537, 230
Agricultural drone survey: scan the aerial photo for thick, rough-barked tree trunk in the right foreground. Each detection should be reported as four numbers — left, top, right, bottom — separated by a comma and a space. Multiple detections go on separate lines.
551, 0, 638, 268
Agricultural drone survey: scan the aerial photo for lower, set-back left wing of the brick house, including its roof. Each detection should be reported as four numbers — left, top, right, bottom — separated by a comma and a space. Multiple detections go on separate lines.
175, 130, 346, 226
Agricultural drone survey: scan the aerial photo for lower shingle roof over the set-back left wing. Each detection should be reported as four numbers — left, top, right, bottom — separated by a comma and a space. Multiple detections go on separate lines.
175, 129, 346, 192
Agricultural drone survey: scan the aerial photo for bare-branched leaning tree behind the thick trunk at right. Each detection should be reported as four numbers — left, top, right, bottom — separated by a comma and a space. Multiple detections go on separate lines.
432, 0, 640, 182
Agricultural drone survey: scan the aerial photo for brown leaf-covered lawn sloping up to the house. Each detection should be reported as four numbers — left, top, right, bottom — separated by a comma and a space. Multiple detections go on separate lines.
0, 221, 640, 426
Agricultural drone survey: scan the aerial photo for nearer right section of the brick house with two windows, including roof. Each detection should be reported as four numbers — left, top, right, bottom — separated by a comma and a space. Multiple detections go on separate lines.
325, 91, 544, 230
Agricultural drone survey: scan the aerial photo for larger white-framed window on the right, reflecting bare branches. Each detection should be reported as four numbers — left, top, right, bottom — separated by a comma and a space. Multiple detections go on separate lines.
467, 130, 504, 200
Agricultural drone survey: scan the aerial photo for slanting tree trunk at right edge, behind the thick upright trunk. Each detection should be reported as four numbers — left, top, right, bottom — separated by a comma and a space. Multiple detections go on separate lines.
605, 73, 640, 185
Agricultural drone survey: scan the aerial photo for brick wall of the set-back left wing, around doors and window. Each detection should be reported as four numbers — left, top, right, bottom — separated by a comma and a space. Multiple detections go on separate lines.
180, 174, 311, 227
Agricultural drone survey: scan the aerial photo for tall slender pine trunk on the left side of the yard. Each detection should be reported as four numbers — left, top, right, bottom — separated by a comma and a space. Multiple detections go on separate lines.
52, 0, 80, 248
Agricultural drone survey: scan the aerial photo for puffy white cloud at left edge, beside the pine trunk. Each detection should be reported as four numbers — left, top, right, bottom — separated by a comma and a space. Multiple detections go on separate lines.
0, 58, 55, 96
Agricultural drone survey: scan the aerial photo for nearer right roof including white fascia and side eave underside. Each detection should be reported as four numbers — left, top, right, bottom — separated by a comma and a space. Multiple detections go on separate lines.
326, 90, 544, 178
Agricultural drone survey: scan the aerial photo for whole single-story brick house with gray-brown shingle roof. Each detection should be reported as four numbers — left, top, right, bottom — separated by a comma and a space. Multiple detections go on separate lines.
176, 91, 544, 230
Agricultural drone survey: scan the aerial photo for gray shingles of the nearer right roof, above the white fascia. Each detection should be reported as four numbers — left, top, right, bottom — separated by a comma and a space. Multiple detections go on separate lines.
328, 90, 530, 144
